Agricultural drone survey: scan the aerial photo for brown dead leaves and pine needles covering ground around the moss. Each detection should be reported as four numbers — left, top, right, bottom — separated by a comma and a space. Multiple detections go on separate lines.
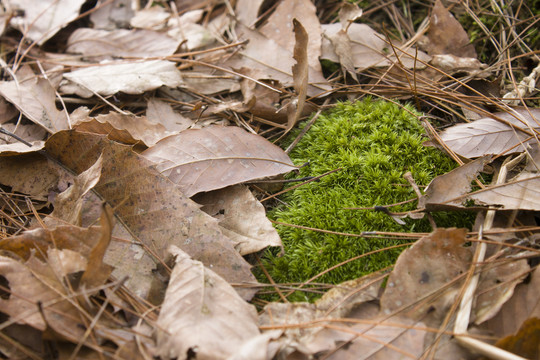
0, 0, 540, 360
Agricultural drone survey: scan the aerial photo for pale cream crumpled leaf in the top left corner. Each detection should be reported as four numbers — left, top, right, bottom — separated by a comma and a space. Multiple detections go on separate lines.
9, 0, 84, 45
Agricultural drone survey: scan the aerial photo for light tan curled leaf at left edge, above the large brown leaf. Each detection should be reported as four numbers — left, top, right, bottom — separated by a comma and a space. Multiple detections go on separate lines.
0, 66, 70, 133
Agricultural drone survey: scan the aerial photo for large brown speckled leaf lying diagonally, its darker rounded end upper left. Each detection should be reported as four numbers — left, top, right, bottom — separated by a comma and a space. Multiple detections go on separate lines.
46, 131, 255, 297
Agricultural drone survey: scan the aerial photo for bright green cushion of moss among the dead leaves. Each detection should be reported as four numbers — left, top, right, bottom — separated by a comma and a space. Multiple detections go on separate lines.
259, 99, 472, 300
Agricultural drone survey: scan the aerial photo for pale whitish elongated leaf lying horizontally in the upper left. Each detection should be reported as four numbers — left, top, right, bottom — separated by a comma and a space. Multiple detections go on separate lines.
64, 60, 182, 95
